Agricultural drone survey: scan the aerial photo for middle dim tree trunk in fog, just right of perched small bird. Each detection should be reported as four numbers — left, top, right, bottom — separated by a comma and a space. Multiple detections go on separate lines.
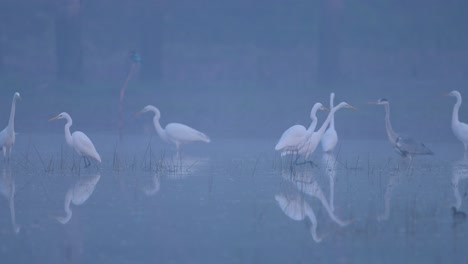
139, 0, 164, 82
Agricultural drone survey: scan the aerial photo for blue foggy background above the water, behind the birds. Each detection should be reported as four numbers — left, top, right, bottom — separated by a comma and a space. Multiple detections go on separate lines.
0, 0, 468, 144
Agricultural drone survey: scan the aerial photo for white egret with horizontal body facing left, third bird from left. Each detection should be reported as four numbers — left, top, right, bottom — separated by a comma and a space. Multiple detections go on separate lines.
137, 105, 210, 157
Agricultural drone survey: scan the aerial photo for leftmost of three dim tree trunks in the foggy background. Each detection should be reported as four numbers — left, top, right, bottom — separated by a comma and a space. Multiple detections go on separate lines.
55, 0, 83, 83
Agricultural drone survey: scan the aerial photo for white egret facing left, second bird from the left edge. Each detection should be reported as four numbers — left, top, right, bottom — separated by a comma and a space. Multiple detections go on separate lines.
49, 112, 101, 168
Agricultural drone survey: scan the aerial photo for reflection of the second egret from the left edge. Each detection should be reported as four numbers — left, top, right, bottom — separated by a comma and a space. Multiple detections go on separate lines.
53, 173, 101, 224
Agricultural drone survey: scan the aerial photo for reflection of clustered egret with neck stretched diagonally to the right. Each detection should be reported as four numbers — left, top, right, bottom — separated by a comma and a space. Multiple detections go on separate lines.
289, 172, 351, 227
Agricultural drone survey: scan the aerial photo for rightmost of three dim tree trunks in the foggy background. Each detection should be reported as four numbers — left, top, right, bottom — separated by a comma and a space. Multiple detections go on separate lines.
317, 0, 343, 84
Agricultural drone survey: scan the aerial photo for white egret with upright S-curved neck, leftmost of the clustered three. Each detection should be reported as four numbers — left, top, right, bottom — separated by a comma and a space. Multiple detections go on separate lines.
275, 103, 329, 156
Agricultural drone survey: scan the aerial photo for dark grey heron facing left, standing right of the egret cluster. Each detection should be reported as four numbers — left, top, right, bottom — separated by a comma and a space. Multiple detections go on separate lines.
369, 98, 434, 160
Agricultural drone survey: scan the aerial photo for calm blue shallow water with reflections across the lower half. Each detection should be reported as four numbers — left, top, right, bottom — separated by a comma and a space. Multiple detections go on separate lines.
0, 135, 468, 263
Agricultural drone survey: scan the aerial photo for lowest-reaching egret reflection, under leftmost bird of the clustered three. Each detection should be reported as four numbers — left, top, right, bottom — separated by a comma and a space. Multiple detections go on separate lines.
275, 194, 322, 243
